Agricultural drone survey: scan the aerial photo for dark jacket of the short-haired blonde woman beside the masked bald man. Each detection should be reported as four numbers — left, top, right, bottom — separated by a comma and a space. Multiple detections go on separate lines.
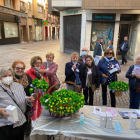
65, 62, 82, 82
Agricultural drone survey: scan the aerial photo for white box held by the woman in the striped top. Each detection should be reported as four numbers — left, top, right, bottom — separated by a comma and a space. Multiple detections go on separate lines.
6, 105, 18, 123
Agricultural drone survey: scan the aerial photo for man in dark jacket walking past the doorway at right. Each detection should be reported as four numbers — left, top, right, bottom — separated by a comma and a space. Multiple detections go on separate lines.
120, 36, 130, 65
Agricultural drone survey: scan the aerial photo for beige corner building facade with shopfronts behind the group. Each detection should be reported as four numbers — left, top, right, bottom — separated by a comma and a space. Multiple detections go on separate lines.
51, 0, 140, 60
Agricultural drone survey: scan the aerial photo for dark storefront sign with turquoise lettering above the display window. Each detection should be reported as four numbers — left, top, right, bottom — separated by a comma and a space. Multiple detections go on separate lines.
93, 14, 115, 21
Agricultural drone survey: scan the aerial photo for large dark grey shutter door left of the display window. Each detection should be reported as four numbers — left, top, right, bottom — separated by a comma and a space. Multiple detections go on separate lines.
64, 15, 81, 54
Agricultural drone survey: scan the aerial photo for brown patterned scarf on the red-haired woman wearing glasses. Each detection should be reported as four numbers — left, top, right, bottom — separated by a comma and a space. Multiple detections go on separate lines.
13, 73, 29, 88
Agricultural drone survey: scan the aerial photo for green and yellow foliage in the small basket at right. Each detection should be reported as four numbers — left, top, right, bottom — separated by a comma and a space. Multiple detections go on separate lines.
108, 81, 129, 91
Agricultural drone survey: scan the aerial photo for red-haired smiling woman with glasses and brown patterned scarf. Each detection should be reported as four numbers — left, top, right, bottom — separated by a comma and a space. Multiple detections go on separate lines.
12, 61, 32, 136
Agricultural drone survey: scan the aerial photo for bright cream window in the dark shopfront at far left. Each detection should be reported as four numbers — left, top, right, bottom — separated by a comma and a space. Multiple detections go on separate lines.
4, 22, 18, 38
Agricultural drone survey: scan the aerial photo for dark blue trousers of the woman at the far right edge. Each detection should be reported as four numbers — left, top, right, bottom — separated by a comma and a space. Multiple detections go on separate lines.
129, 88, 140, 109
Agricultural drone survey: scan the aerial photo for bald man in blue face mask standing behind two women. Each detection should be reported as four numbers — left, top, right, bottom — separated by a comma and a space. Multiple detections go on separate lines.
78, 46, 89, 65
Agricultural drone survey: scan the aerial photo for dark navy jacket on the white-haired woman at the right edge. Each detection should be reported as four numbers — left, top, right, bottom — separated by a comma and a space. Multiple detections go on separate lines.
125, 65, 140, 89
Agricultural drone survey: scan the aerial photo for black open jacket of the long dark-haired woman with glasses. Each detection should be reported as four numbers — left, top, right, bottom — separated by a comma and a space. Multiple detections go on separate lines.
80, 64, 100, 88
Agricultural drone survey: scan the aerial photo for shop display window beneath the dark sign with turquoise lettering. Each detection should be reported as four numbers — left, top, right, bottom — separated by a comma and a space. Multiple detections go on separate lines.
90, 23, 114, 51
